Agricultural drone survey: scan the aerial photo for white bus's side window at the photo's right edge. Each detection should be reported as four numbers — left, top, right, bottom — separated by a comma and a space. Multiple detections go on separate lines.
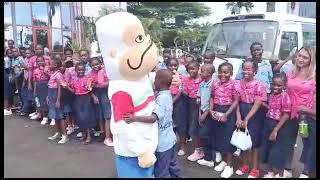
302, 24, 316, 46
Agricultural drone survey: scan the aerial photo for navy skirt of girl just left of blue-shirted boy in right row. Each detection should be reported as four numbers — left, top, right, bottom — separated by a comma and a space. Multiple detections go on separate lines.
187, 97, 201, 137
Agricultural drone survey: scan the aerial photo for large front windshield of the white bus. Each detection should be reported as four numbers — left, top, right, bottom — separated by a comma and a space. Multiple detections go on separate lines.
203, 20, 278, 59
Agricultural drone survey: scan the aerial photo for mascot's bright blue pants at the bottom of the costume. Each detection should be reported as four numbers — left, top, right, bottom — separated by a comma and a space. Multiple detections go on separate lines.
115, 154, 154, 178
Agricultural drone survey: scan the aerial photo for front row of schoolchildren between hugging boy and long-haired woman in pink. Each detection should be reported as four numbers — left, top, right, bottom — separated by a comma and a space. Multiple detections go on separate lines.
166, 46, 315, 178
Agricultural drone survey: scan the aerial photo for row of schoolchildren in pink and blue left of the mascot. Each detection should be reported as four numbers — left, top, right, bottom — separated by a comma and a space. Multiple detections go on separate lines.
5, 46, 113, 146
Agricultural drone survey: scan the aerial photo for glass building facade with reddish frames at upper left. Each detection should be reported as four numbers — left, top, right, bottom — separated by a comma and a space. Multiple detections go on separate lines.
4, 2, 82, 52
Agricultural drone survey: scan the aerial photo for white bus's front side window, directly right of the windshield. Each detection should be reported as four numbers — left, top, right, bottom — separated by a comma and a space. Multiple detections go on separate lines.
279, 31, 298, 60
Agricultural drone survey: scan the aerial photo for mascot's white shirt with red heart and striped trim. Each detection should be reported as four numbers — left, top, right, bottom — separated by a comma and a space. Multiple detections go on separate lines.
108, 76, 158, 157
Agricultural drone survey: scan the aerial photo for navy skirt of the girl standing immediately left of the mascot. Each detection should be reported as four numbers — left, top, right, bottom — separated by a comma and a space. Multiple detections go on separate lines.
93, 88, 111, 121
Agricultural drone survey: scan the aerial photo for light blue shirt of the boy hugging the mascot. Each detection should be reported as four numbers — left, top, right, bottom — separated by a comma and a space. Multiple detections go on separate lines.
153, 90, 176, 152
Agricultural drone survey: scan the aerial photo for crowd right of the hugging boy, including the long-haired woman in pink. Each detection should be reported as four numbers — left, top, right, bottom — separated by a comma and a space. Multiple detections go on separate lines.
158, 42, 316, 178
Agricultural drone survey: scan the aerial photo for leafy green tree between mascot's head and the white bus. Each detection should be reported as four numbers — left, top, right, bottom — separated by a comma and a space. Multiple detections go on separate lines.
127, 2, 210, 48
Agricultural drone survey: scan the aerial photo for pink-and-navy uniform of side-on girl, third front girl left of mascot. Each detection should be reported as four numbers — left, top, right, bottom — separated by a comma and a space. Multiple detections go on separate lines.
48, 71, 63, 121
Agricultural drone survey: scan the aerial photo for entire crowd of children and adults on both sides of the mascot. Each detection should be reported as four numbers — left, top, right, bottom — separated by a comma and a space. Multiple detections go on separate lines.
4, 38, 316, 178
